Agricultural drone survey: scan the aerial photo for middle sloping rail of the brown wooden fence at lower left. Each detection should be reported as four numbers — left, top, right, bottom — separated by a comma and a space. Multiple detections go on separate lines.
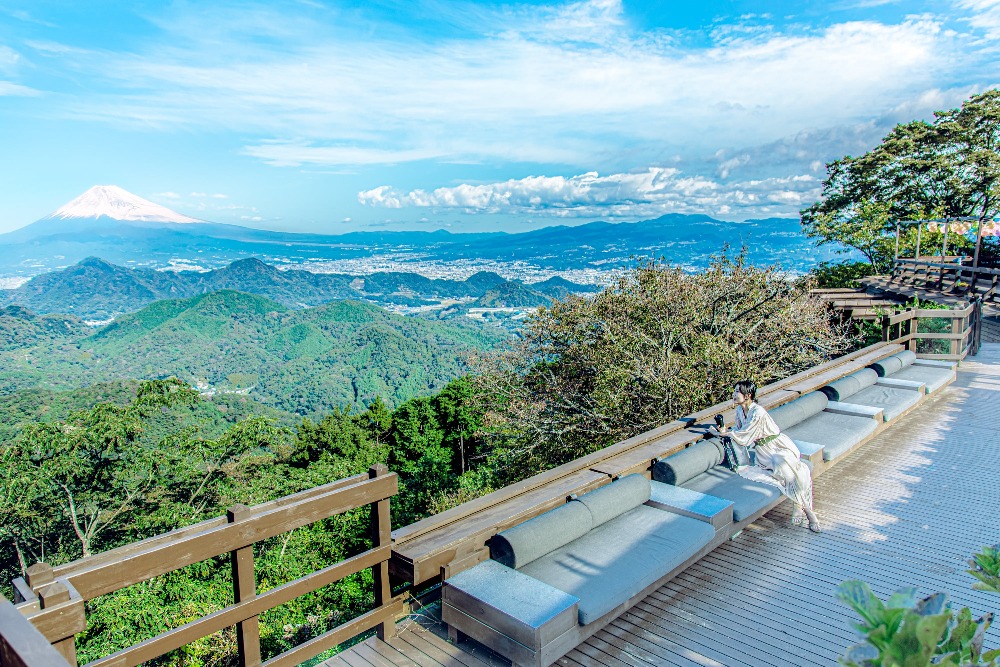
87, 546, 391, 667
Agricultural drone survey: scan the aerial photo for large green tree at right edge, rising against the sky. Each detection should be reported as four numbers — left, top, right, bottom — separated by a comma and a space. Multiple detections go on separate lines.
801, 90, 1000, 273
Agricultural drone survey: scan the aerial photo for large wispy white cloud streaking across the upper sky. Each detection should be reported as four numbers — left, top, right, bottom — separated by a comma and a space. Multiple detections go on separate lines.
45, 0, 961, 175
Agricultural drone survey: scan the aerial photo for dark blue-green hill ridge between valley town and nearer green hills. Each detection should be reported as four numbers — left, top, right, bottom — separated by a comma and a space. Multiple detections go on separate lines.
0, 257, 599, 320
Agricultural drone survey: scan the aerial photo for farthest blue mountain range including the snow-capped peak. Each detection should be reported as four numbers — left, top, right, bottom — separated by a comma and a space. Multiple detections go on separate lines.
0, 186, 833, 277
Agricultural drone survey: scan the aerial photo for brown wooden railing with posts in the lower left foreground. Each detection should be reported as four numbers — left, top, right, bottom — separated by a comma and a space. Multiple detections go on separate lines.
0, 465, 403, 667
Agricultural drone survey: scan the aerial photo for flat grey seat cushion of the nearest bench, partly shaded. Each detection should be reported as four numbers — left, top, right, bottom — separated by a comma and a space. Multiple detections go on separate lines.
520, 505, 715, 625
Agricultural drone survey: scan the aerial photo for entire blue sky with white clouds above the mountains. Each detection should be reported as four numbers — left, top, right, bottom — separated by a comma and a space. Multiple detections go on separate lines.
0, 0, 1000, 233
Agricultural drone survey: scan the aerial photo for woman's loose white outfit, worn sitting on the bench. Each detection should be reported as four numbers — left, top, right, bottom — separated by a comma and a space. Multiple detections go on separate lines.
726, 403, 812, 509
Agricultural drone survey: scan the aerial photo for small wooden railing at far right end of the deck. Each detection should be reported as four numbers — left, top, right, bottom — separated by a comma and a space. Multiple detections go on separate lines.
882, 298, 982, 361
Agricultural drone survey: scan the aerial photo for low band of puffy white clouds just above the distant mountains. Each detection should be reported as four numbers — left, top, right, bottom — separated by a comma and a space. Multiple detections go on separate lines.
358, 167, 820, 219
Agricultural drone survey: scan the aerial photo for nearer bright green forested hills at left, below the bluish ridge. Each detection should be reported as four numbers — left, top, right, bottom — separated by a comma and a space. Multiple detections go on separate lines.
0, 290, 507, 415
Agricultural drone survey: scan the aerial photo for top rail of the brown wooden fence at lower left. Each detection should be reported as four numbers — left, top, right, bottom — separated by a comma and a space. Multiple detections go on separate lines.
67, 473, 397, 600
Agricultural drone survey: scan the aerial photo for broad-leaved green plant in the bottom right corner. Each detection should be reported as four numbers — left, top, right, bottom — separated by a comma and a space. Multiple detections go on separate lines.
836, 546, 1000, 667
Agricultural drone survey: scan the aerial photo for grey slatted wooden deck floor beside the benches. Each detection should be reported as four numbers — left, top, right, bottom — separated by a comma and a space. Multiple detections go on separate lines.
325, 343, 1000, 667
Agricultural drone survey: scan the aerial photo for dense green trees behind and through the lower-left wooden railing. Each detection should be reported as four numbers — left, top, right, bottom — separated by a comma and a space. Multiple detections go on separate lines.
0, 379, 478, 666
